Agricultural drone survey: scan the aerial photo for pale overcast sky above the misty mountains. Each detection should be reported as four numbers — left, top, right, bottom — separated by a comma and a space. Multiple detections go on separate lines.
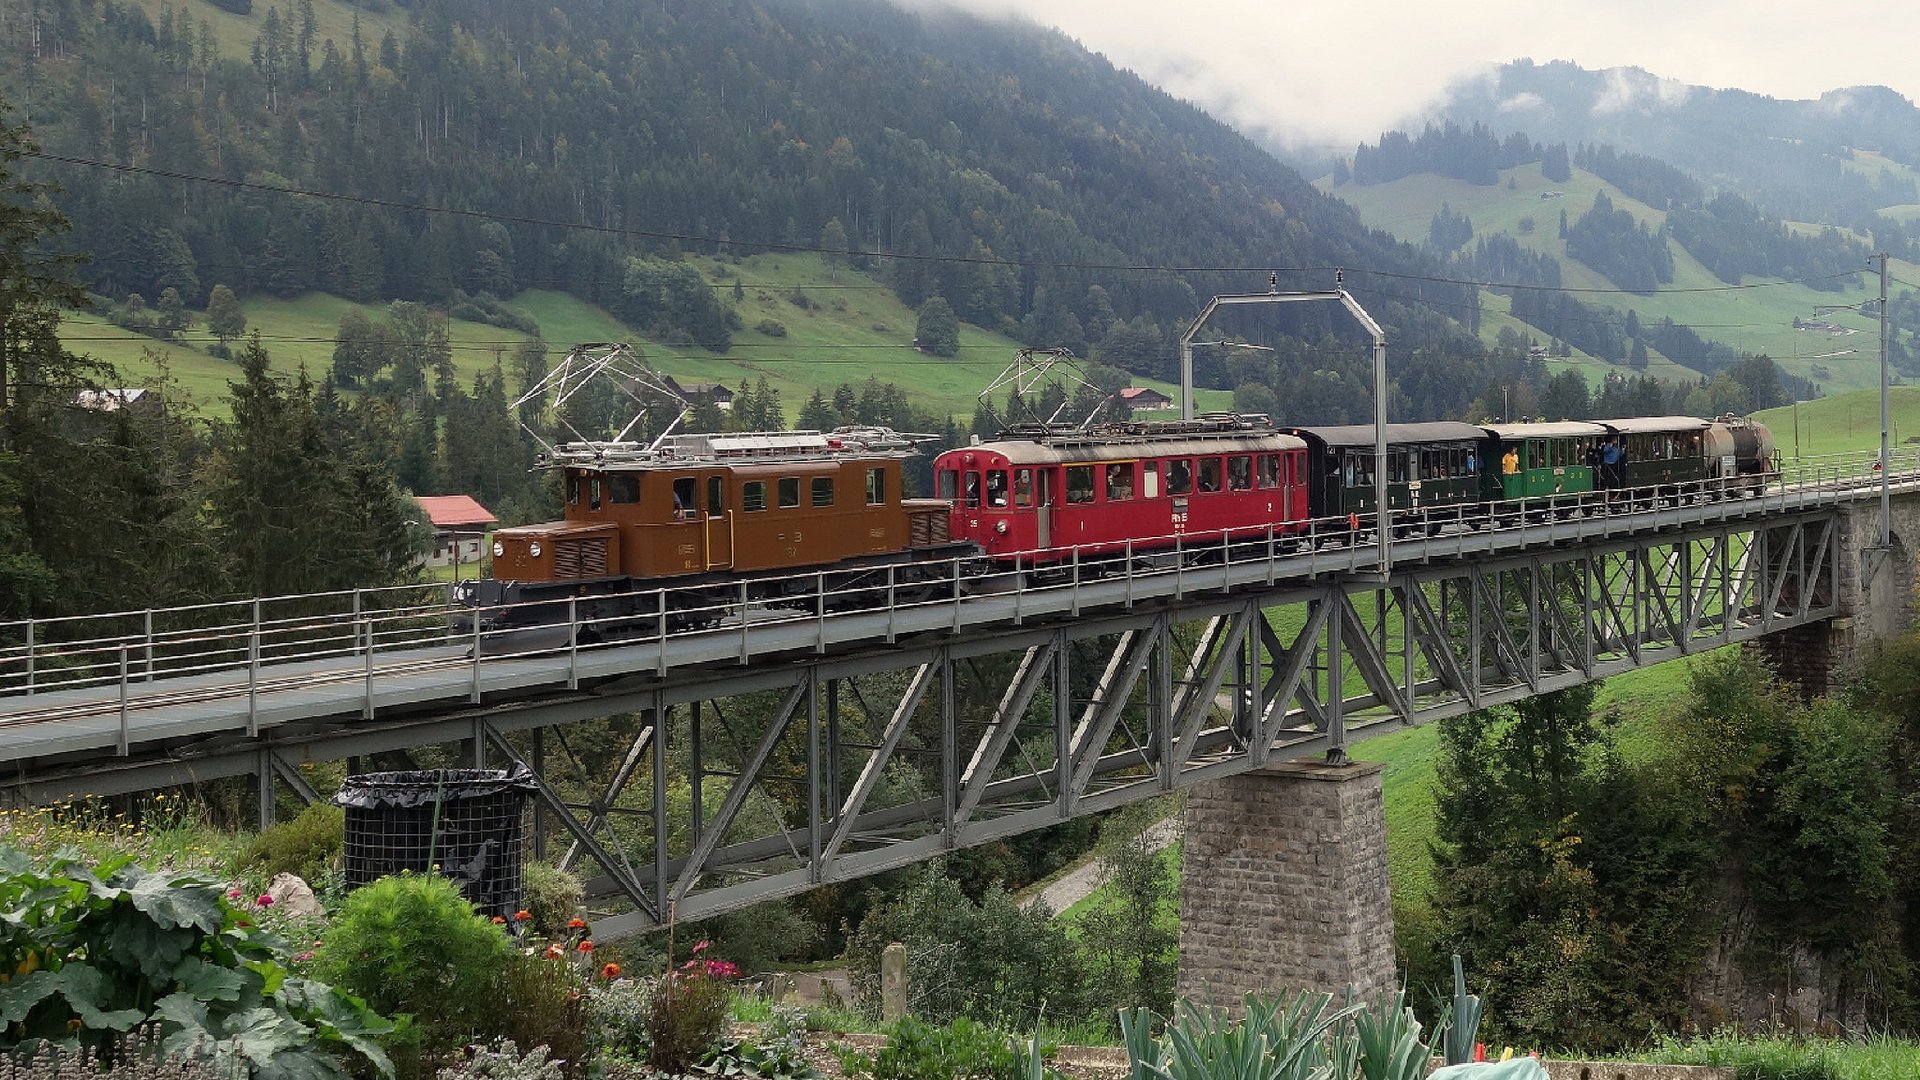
918, 0, 1920, 150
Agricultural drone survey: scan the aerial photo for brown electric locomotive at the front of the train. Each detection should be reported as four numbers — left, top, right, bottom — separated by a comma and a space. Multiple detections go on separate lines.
455, 429, 972, 630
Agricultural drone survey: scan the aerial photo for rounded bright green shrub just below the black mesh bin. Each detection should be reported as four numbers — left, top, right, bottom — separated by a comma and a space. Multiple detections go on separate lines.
313, 872, 516, 1053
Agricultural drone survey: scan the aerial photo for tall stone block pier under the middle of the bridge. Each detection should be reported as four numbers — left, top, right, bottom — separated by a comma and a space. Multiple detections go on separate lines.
1179, 761, 1398, 1005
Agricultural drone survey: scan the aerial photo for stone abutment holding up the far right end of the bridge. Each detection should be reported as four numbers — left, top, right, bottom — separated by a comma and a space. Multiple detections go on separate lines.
1747, 492, 1920, 698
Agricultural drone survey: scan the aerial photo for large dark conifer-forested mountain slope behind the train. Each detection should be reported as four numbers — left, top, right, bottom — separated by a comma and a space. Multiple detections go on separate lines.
18, 0, 1473, 399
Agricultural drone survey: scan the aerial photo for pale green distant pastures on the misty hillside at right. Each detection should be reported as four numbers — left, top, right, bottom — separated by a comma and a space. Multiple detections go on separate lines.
1317, 163, 1920, 392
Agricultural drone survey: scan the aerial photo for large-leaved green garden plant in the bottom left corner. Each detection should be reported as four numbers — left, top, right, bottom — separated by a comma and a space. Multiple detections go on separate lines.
0, 847, 394, 1080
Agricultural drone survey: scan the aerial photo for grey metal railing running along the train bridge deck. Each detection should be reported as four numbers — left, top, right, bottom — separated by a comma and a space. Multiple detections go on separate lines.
0, 448, 1920, 719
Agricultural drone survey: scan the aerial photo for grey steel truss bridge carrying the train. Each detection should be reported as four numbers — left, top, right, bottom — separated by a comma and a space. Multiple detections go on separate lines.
0, 459, 1920, 938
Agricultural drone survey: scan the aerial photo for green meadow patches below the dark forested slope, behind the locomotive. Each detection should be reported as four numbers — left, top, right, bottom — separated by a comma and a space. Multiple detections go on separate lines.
61, 254, 1233, 423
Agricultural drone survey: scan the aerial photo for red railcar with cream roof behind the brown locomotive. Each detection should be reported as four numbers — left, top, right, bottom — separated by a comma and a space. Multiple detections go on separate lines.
933, 417, 1308, 565
